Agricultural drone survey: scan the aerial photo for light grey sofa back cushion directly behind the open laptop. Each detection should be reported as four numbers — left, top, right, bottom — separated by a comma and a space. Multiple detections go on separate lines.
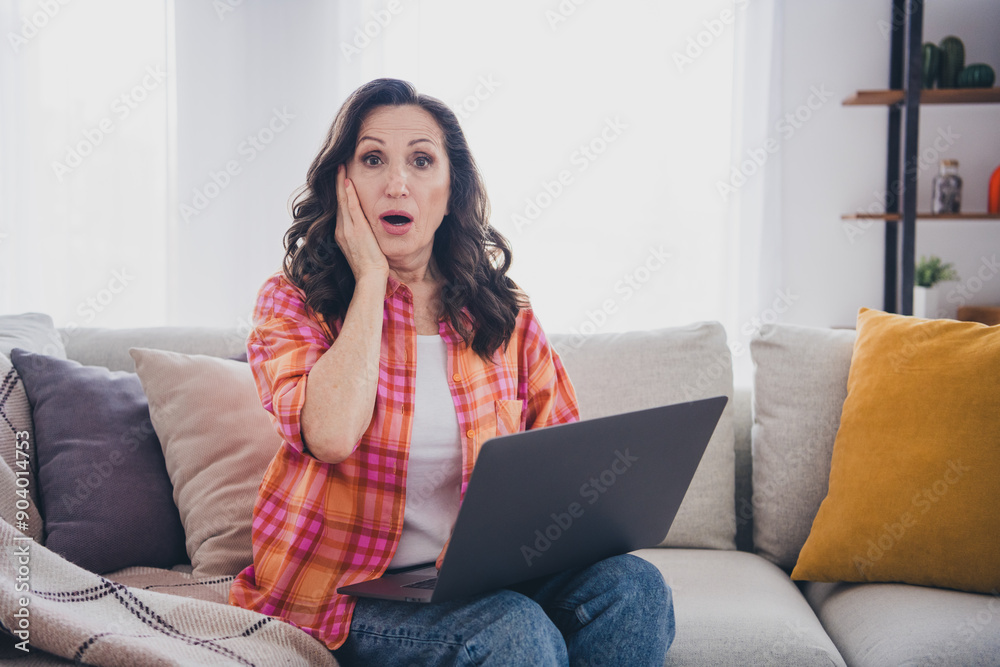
549, 322, 736, 549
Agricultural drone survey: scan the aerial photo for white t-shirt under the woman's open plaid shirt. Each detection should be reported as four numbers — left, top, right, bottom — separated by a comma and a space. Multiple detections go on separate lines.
389, 335, 462, 568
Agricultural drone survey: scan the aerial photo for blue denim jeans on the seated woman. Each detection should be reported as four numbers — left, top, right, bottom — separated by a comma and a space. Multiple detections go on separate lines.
333, 554, 674, 667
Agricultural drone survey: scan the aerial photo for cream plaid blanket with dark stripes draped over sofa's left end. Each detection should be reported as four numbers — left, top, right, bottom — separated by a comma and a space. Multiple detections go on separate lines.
0, 520, 337, 667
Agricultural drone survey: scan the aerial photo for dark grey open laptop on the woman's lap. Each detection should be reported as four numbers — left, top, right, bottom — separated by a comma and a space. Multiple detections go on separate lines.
337, 396, 728, 602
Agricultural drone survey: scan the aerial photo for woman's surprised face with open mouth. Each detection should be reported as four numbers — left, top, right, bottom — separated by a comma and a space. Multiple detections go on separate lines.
347, 105, 451, 271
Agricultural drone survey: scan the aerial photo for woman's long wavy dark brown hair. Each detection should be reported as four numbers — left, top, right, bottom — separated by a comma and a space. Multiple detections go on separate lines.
282, 79, 528, 360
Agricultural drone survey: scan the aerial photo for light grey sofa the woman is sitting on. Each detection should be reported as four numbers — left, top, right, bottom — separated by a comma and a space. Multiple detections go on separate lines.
4, 323, 1000, 666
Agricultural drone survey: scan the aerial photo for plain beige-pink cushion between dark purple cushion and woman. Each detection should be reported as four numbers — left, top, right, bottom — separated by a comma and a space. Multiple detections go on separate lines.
129, 348, 281, 577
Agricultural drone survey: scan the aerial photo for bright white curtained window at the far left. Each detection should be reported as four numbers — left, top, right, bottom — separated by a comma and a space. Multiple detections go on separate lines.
0, 0, 167, 326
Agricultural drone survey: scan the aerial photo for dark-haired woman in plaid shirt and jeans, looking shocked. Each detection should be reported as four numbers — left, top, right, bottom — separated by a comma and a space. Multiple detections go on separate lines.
229, 79, 674, 665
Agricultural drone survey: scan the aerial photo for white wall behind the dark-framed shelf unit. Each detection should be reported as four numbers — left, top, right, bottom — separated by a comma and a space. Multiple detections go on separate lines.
781, 0, 1000, 326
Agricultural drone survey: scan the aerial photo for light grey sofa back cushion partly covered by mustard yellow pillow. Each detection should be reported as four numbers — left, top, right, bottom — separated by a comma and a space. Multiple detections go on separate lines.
738, 324, 856, 571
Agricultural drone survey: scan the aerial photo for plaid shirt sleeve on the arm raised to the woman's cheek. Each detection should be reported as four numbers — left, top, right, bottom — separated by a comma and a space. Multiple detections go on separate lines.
247, 272, 333, 453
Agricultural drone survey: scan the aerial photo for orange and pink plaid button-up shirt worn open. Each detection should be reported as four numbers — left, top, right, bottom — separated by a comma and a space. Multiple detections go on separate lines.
229, 272, 579, 649
